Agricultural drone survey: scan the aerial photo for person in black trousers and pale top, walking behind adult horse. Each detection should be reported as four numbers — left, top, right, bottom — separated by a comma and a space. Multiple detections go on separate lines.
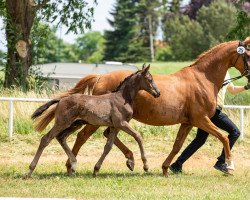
169, 72, 250, 173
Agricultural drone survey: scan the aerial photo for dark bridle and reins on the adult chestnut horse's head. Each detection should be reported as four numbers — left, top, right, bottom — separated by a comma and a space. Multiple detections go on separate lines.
222, 41, 250, 87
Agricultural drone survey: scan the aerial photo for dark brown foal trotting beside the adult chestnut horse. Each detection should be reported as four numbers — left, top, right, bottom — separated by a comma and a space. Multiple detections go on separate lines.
24, 65, 160, 178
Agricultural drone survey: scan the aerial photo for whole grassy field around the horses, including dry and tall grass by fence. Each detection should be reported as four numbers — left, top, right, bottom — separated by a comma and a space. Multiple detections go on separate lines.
0, 62, 250, 199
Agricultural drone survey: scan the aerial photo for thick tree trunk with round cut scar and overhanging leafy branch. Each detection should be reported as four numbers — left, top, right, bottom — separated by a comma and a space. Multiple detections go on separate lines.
0, 0, 93, 89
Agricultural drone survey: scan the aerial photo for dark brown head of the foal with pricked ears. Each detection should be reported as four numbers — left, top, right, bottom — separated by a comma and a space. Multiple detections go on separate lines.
139, 64, 160, 97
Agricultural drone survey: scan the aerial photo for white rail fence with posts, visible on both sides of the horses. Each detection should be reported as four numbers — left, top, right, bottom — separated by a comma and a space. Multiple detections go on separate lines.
0, 97, 250, 139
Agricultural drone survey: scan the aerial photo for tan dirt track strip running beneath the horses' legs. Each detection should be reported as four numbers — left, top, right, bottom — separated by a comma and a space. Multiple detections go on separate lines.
0, 134, 250, 172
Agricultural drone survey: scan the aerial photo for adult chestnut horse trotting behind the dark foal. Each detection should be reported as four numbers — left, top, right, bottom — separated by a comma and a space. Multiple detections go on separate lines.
33, 37, 250, 176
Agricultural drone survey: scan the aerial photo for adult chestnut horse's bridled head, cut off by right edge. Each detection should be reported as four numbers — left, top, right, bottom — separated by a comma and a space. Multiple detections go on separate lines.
232, 37, 250, 82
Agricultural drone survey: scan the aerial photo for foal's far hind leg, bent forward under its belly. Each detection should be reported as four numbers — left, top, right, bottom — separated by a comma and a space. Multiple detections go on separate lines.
56, 121, 83, 175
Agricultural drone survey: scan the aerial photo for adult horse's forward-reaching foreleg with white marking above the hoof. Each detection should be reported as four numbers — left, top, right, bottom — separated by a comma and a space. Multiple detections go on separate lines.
197, 117, 234, 174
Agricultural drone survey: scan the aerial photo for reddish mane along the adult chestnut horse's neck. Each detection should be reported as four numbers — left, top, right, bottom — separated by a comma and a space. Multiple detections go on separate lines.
191, 41, 235, 66
